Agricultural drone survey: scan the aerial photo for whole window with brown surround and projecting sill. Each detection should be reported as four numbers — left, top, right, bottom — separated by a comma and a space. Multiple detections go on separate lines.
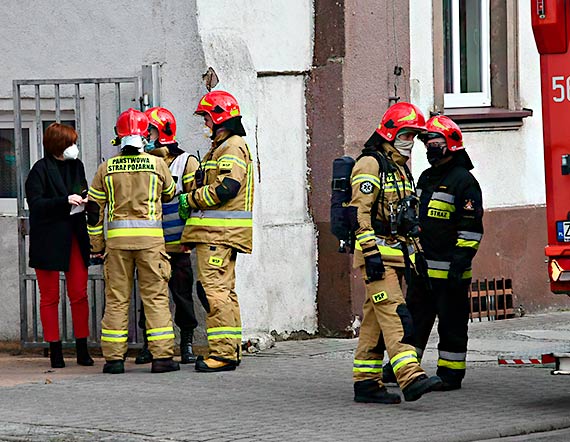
432, 0, 532, 131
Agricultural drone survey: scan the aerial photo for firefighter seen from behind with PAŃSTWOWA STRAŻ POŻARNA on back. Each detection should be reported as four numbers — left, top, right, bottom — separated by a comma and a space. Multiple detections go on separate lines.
87, 109, 180, 374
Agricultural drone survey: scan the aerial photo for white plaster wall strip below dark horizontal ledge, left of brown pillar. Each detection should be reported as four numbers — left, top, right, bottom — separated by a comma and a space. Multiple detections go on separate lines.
238, 77, 317, 333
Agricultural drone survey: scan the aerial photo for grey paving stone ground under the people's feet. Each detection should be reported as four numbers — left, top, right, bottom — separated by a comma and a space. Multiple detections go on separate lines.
0, 312, 570, 442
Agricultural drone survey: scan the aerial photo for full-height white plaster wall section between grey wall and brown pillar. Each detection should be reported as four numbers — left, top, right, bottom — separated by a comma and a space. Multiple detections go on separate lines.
197, 0, 317, 337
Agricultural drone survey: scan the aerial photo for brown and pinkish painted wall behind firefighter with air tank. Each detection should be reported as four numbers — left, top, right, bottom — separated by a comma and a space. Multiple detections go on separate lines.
307, 0, 409, 336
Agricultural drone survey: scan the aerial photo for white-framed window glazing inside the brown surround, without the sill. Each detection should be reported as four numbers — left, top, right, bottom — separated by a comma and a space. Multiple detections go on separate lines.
443, 0, 491, 108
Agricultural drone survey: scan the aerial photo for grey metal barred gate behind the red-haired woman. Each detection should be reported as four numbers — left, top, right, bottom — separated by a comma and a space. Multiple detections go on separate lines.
13, 65, 160, 348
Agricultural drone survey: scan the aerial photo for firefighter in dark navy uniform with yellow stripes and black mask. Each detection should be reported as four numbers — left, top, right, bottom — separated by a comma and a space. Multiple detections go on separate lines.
406, 116, 483, 390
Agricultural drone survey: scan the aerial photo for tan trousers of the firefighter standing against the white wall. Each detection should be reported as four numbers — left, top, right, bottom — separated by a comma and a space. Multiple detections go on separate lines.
196, 244, 241, 362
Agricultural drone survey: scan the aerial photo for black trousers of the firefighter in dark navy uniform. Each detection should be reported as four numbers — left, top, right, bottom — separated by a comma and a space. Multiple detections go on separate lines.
406, 276, 471, 384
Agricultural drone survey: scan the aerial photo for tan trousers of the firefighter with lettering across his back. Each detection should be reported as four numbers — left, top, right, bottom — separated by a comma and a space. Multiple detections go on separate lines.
101, 245, 174, 361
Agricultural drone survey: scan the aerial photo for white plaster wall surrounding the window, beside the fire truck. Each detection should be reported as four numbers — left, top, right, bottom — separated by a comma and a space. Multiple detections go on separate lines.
410, 2, 545, 208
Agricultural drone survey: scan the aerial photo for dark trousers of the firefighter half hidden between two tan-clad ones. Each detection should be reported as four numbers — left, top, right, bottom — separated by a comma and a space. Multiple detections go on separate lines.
138, 253, 198, 331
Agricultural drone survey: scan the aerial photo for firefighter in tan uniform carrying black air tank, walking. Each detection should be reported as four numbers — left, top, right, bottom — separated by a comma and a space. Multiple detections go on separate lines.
349, 103, 441, 404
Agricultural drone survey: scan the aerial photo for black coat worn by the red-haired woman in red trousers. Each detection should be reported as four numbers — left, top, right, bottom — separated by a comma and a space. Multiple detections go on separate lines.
26, 155, 90, 272
